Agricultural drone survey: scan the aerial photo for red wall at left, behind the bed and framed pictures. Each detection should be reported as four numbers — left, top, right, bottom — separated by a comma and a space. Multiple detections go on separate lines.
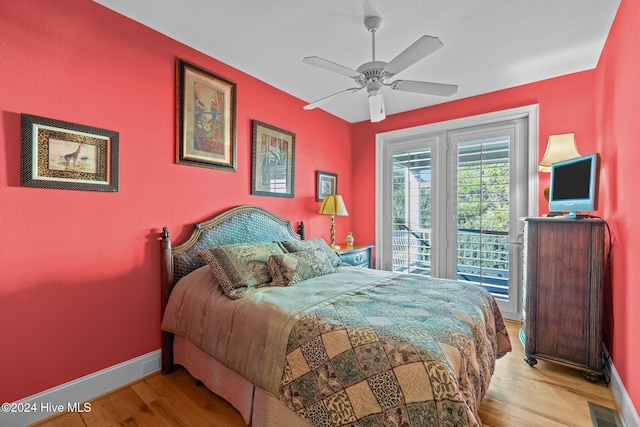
0, 0, 352, 402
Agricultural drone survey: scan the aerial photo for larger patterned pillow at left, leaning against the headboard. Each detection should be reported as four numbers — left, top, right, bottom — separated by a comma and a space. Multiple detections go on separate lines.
198, 242, 284, 299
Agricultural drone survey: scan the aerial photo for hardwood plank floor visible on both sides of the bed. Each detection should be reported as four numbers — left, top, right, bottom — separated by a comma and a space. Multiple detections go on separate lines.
35, 322, 616, 427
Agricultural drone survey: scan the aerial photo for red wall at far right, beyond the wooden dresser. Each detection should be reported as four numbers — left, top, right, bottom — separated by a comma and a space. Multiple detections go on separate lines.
595, 0, 640, 413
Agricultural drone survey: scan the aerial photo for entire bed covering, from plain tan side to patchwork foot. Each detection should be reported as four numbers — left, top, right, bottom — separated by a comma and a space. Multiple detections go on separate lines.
162, 267, 511, 427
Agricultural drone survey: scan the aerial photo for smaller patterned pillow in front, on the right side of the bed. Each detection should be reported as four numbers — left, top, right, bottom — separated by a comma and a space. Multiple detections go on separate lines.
269, 249, 336, 286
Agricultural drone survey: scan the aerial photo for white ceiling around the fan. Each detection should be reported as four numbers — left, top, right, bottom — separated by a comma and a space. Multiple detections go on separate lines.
95, 0, 620, 123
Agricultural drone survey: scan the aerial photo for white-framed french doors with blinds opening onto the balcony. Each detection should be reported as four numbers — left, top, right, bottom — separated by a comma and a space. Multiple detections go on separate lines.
376, 105, 537, 318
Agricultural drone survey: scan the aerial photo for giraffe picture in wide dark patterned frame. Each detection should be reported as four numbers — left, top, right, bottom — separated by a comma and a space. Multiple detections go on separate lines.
20, 114, 119, 192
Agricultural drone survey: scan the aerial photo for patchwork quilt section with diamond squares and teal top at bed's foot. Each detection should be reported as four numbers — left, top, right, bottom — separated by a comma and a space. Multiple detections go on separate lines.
280, 275, 511, 426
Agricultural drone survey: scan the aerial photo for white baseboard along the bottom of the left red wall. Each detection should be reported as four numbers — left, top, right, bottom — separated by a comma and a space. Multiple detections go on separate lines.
0, 350, 162, 427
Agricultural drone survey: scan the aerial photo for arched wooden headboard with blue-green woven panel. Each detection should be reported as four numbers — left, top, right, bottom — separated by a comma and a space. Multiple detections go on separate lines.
160, 205, 304, 373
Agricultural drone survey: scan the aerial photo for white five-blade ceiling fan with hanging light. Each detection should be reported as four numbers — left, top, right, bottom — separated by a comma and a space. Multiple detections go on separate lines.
302, 16, 458, 122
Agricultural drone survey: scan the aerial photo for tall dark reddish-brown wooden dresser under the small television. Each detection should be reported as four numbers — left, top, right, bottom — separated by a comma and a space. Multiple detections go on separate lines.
523, 217, 605, 373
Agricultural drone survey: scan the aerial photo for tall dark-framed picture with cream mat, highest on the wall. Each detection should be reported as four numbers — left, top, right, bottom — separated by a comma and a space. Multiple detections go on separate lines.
176, 59, 236, 171
